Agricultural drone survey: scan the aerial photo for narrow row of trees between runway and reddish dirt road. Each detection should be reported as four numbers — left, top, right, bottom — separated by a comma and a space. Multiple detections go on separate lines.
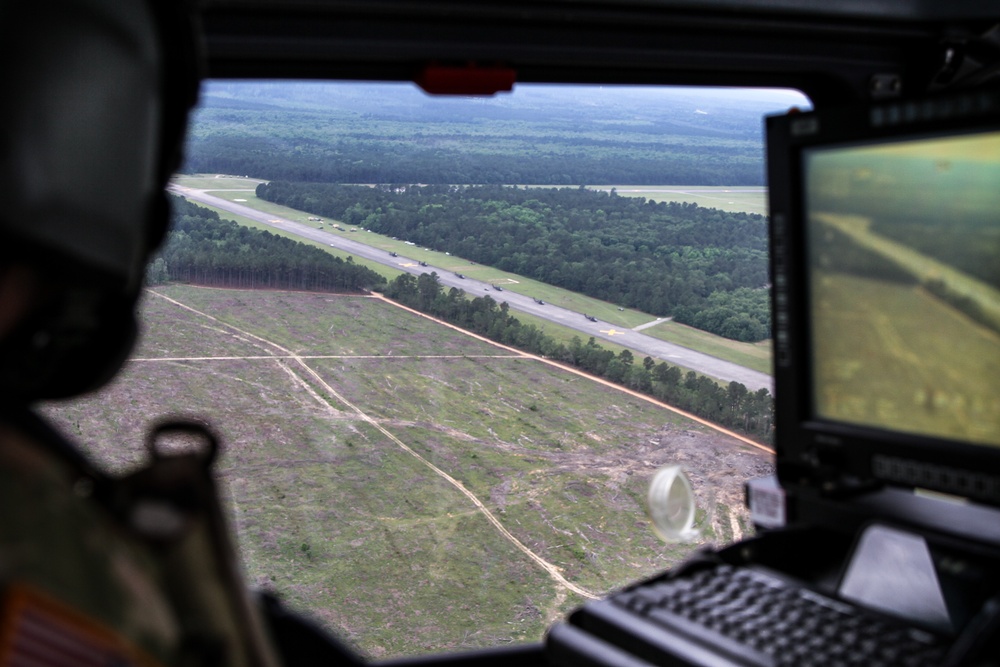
385, 273, 774, 441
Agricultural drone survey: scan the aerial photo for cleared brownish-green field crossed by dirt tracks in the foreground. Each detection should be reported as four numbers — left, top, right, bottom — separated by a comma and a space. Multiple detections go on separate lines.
44, 286, 770, 658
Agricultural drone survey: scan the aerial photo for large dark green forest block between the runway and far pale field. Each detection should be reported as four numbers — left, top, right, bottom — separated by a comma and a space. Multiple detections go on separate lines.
257, 182, 771, 342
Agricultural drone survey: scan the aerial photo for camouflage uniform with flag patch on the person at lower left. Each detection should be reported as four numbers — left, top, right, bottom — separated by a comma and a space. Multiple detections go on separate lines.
0, 413, 277, 666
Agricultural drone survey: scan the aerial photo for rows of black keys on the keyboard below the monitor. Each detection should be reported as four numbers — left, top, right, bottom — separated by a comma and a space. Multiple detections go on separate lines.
611, 565, 947, 667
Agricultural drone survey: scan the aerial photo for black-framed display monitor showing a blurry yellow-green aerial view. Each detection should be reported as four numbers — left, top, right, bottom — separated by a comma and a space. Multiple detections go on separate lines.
768, 93, 1000, 505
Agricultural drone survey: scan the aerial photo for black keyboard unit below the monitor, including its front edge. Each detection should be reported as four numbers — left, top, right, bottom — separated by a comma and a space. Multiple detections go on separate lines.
547, 564, 950, 667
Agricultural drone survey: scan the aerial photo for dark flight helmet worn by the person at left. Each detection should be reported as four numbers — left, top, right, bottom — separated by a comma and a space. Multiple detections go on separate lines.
0, 0, 199, 402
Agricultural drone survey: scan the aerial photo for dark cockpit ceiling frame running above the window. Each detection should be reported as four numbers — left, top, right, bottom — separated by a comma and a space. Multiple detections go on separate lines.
197, 0, 1000, 104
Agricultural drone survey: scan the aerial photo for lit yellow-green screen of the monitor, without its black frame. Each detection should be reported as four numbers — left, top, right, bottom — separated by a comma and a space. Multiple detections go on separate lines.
802, 131, 1000, 445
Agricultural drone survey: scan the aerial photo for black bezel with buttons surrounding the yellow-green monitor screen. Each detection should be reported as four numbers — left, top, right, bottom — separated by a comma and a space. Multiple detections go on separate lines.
766, 92, 1000, 507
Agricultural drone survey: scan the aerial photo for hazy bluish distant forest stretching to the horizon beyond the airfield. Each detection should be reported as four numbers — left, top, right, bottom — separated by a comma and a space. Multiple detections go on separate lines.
184, 82, 788, 185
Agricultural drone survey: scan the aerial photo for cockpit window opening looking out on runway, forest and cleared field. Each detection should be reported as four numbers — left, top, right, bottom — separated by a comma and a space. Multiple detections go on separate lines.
44, 81, 808, 658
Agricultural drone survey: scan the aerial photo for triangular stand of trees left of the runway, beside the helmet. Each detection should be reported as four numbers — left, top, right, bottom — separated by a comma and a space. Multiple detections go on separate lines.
146, 197, 385, 292
